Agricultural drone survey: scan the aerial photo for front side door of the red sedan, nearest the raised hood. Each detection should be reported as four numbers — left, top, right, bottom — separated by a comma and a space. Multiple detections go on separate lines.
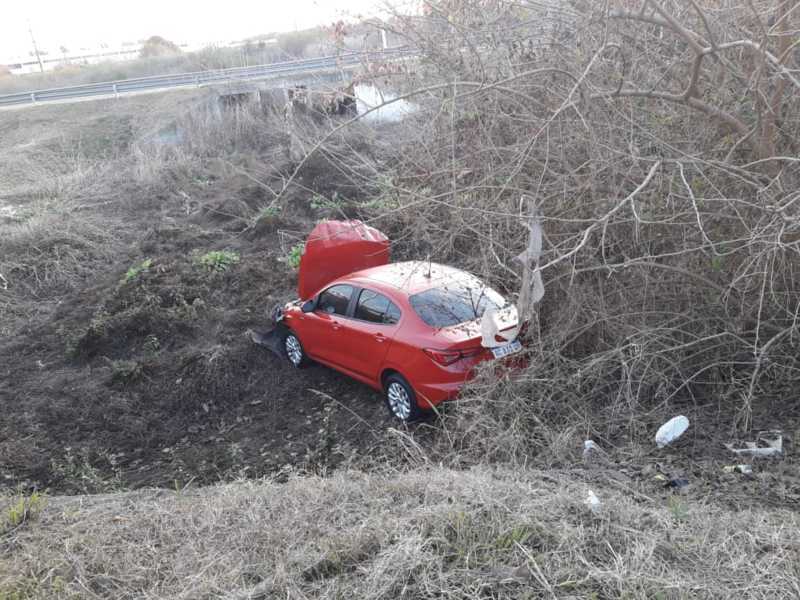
299, 284, 355, 365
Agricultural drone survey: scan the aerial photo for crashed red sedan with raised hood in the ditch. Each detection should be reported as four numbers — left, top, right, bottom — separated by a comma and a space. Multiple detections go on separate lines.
275, 221, 522, 421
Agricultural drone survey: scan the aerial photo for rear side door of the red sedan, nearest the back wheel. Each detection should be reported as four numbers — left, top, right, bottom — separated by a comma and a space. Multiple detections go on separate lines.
334, 288, 402, 380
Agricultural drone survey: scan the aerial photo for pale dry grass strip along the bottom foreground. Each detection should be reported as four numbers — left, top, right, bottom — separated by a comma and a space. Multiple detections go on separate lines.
0, 469, 800, 599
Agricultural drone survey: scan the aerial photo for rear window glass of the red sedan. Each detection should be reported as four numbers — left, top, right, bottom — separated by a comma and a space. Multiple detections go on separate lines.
409, 280, 508, 328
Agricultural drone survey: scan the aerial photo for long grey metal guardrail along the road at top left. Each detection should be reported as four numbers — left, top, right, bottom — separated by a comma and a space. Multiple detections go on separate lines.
0, 48, 413, 107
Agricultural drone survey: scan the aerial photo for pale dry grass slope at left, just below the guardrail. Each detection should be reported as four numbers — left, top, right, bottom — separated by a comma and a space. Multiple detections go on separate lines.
0, 90, 288, 335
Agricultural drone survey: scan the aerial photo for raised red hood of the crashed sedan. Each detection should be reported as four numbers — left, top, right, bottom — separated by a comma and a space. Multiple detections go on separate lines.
297, 220, 389, 300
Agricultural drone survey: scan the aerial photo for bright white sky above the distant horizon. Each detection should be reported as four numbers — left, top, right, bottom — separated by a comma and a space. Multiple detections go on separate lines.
0, 0, 388, 63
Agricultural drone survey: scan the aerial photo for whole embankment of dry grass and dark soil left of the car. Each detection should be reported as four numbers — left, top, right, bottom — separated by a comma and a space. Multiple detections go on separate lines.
0, 91, 396, 492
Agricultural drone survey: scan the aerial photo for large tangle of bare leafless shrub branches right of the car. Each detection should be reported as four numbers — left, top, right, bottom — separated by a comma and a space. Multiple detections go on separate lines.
282, 0, 800, 446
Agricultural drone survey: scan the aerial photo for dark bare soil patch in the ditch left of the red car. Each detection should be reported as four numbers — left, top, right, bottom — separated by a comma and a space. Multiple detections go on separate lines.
0, 225, 396, 491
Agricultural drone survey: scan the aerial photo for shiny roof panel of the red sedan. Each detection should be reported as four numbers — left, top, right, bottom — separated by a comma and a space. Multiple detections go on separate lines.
343, 260, 475, 295
